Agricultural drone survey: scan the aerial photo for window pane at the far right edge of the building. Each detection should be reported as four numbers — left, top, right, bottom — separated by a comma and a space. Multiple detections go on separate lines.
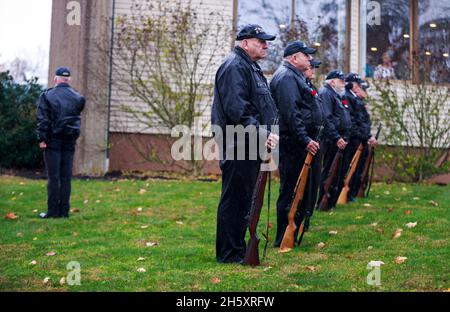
418, 0, 450, 83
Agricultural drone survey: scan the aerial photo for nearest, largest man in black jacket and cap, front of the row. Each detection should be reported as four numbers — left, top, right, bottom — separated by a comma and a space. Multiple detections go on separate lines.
211, 25, 278, 263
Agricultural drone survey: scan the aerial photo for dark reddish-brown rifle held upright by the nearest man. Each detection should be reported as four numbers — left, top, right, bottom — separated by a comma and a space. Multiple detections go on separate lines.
243, 116, 278, 266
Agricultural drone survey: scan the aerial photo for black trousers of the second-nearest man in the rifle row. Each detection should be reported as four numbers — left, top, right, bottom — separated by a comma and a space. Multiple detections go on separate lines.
274, 136, 322, 247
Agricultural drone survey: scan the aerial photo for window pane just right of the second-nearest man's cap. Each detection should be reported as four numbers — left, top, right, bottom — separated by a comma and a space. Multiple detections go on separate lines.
295, 0, 346, 73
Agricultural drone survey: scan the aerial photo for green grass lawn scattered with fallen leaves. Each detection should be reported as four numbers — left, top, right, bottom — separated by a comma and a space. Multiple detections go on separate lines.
0, 176, 450, 291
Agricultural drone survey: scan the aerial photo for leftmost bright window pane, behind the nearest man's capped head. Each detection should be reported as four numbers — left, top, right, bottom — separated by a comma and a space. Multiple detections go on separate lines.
237, 0, 292, 73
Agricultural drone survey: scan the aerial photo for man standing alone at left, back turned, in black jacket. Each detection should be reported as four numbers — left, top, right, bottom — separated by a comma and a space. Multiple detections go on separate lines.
37, 67, 85, 219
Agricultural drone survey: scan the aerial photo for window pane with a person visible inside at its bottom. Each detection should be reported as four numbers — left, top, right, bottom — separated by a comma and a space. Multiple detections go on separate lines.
363, 0, 410, 79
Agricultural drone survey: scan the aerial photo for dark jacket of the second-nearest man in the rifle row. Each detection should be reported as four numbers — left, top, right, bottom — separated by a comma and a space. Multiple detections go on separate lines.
270, 62, 323, 148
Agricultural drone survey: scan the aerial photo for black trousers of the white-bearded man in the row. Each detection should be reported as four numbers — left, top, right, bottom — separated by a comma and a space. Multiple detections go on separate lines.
319, 141, 345, 210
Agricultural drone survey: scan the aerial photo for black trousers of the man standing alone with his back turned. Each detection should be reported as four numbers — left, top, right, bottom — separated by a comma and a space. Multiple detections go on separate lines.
44, 139, 75, 217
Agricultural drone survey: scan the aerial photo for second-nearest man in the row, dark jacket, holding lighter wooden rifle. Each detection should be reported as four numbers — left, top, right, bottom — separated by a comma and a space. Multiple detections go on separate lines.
270, 41, 323, 247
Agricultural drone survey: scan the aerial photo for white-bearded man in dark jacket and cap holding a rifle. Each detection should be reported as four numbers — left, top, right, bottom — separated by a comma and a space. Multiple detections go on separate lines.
319, 70, 352, 210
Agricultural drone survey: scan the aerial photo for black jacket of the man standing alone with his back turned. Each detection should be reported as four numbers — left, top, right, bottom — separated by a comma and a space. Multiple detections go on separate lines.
36, 83, 86, 142
